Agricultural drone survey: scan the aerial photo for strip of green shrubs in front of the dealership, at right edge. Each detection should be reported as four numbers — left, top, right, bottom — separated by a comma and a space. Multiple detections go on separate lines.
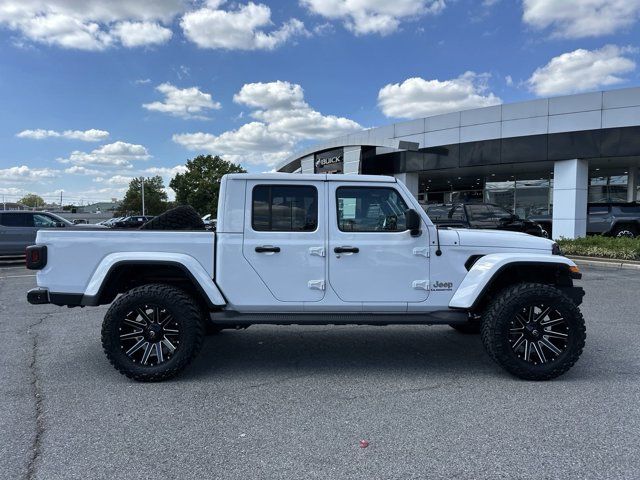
558, 235, 640, 260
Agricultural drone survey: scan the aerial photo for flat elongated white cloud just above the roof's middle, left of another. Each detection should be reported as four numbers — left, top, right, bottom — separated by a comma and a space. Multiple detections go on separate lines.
378, 72, 502, 118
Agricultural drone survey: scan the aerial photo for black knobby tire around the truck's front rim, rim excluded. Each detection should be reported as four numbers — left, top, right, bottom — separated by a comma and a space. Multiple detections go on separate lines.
481, 283, 586, 380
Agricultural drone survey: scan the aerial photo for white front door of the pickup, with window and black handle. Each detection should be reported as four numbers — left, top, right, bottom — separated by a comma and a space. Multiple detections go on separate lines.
327, 182, 429, 304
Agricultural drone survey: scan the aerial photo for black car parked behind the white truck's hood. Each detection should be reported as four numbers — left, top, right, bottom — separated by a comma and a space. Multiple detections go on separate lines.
424, 203, 544, 237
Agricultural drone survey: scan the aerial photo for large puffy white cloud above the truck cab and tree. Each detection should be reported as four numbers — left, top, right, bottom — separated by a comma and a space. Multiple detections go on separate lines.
173, 81, 362, 166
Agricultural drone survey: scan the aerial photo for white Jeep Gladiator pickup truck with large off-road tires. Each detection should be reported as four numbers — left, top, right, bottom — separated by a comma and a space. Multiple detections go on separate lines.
27, 174, 585, 381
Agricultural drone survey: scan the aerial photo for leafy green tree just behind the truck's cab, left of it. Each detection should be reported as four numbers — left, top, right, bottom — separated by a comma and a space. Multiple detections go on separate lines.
169, 155, 246, 215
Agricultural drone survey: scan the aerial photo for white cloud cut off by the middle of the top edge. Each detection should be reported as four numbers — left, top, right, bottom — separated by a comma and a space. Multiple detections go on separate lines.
300, 0, 446, 35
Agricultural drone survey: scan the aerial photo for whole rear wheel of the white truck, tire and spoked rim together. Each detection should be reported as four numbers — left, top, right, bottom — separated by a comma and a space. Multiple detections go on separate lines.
102, 284, 204, 382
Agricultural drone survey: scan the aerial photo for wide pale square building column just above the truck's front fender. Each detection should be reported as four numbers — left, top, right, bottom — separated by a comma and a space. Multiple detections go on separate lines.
553, 159, 589, 238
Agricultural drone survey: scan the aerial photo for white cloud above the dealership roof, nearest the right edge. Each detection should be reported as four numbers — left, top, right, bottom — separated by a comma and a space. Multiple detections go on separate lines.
527, 45, 636, 96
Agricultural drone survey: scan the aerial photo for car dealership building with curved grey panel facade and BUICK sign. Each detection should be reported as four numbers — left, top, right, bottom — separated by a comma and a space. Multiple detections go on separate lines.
278, 88, 640, 238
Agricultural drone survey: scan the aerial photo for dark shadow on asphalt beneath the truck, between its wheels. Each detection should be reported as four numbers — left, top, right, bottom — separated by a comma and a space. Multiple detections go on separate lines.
181, 326, 500, 378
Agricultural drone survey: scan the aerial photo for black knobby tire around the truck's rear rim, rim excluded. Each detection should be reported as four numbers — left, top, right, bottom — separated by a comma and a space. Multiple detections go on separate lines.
102, 284, 204, 382
